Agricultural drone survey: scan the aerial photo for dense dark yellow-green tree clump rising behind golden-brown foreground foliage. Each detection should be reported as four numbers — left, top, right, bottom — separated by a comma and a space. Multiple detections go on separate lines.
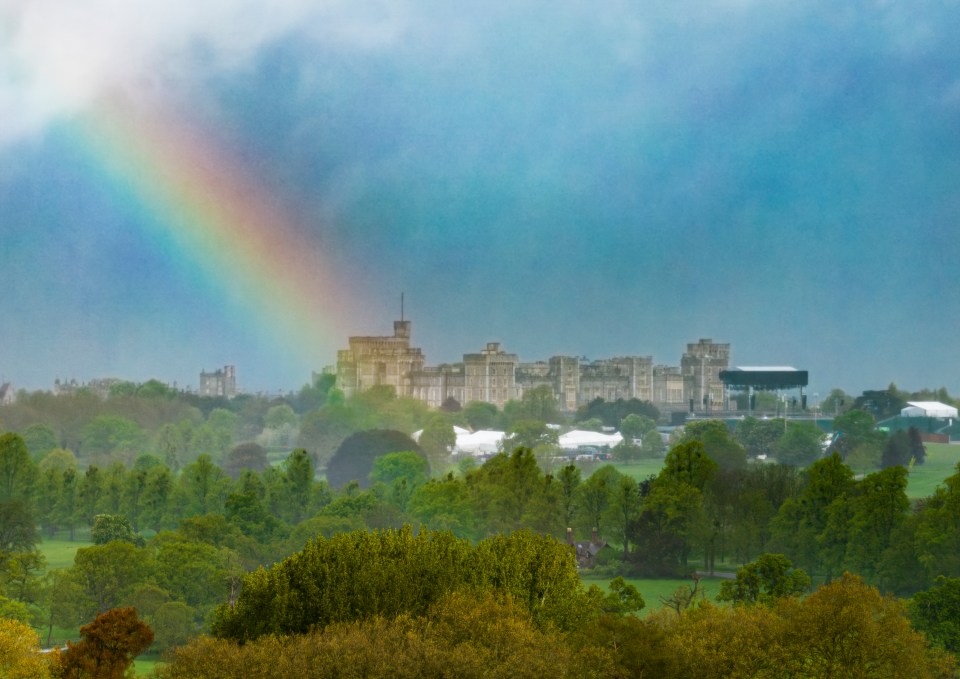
212, 527, 584, 641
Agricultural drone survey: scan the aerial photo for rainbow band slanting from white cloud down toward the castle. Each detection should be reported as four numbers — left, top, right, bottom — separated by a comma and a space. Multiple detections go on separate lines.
73, 95, 350, 368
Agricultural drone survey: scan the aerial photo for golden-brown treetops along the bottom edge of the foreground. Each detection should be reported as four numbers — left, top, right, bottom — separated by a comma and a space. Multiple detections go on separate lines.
158, 575, 956, 679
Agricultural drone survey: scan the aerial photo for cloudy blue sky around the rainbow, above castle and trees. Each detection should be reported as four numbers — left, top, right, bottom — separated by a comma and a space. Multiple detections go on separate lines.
0, 0, 960, 395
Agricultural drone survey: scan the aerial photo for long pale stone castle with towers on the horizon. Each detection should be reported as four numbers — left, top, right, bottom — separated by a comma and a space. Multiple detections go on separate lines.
337, 320, 730, 412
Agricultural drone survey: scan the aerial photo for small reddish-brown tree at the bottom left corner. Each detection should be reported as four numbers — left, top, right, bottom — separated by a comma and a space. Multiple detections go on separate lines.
58, 608, 153, 679
